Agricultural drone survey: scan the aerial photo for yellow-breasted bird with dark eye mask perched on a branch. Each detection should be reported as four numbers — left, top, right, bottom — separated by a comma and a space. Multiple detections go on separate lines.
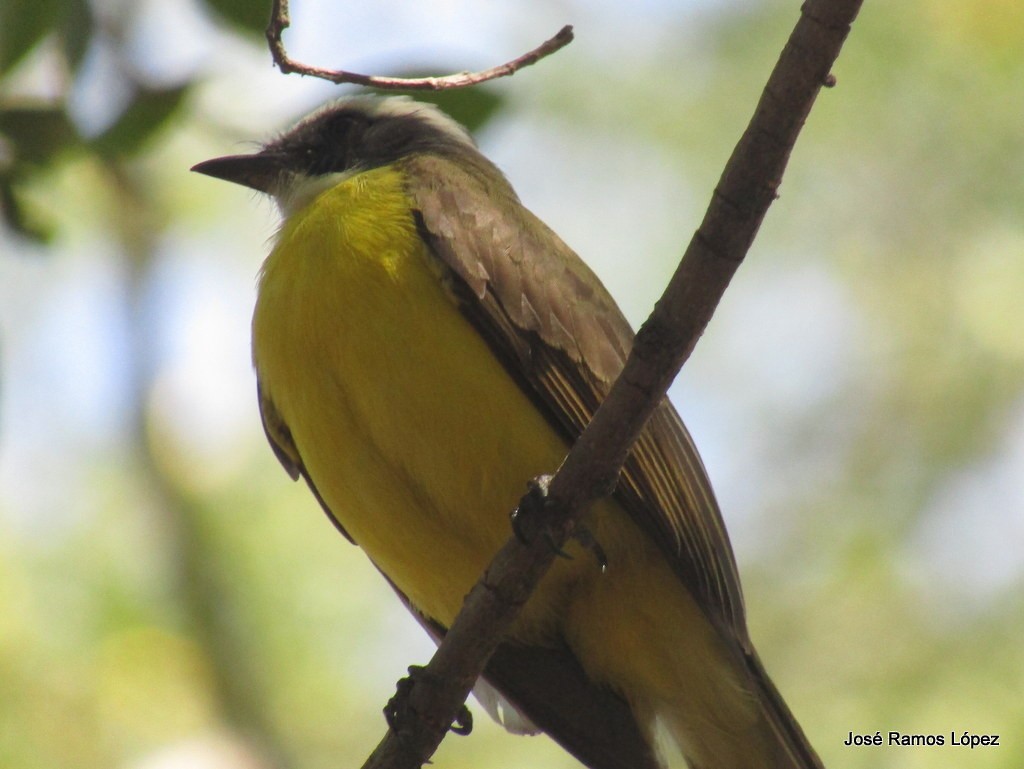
194, 97, 820, 769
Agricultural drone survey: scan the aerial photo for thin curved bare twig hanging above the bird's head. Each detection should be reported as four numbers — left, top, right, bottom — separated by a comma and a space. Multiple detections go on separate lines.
266, 0, 572, 91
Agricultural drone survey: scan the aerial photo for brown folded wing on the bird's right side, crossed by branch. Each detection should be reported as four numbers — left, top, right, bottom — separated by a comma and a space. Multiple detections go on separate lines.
403, 150, 750, 650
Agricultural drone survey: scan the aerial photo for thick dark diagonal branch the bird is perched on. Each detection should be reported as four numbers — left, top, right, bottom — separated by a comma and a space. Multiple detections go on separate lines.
364, 0, 862, 769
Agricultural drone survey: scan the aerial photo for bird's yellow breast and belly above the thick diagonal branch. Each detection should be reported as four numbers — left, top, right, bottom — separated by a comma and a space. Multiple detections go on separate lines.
253, 169, 592, 625
